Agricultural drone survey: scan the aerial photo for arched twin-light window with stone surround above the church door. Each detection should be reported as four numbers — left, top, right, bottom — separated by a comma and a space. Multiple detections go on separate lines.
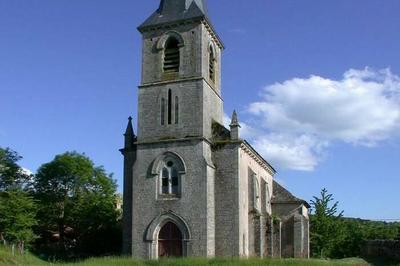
152, 152, 186, 198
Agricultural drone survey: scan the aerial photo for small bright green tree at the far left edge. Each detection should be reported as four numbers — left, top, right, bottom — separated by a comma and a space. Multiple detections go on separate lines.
0, 189, 37, 253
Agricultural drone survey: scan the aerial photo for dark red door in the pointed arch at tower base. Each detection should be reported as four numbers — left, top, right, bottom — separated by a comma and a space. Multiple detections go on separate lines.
158, 222, 183, 258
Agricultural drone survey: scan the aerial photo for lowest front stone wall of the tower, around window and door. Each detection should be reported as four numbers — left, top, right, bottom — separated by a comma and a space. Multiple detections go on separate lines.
132, 140, 215, 258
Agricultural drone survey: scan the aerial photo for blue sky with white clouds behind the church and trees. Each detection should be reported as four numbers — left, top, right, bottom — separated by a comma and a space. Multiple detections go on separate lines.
0, 0, 400, 219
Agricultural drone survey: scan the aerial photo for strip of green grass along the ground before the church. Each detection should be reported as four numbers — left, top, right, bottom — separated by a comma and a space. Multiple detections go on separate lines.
0, 249, 368, 266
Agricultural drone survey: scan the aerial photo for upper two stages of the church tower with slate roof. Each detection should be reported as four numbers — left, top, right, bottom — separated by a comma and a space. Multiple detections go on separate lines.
138, 0, 223, 142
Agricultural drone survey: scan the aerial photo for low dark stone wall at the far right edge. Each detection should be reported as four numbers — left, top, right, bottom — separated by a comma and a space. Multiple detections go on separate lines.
361, 240, 400, 260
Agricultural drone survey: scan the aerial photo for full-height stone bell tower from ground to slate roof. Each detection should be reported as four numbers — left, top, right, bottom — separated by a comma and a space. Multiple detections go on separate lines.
121, 0, 227, 259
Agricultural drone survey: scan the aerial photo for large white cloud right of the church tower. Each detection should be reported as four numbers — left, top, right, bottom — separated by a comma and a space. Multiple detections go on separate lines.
245, 68, 400, 171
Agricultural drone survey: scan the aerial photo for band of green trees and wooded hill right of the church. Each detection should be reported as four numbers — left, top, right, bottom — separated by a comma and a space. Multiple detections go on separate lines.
310, 189, 400, 258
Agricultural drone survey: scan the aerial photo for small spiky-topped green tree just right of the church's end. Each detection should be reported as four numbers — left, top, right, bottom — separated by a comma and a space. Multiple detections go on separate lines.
310, 188, 343, 257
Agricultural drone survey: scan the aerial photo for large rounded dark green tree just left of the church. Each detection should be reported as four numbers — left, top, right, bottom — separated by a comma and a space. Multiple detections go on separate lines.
33, 152, 120, 256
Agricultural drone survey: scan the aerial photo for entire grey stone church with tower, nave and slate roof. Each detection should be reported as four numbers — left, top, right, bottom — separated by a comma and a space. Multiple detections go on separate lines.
121, 0, 309, 259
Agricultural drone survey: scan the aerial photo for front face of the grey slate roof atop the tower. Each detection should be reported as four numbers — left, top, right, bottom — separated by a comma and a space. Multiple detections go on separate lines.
138, 0, 207, 31
